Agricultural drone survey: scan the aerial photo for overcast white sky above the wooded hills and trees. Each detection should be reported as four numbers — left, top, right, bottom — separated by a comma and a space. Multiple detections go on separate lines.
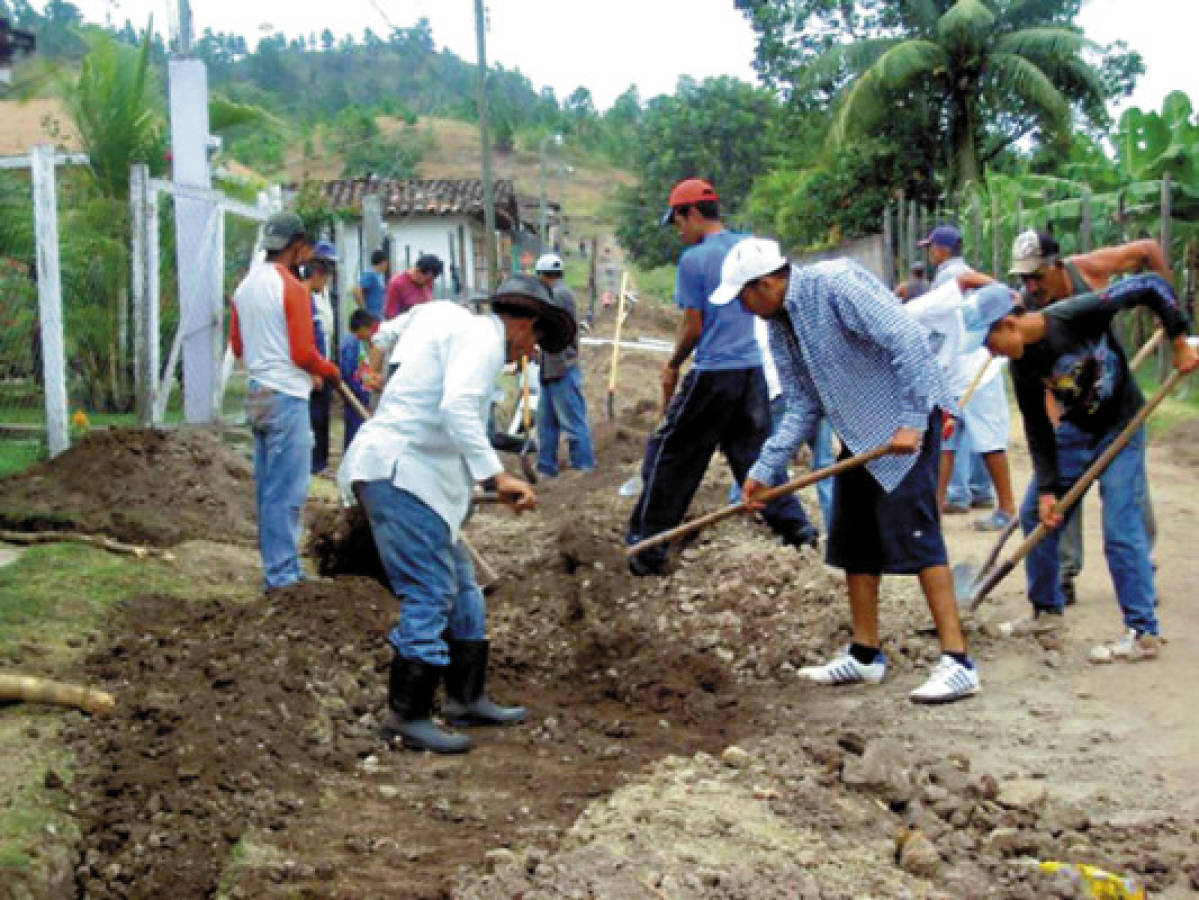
60, 0, 1199, 109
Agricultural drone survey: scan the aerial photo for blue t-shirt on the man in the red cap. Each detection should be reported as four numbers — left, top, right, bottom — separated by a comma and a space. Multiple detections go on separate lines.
675, 231, 761, 372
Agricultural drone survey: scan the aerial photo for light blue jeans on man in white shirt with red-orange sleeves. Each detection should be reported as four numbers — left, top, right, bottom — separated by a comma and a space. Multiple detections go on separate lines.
246, 379, 314, 588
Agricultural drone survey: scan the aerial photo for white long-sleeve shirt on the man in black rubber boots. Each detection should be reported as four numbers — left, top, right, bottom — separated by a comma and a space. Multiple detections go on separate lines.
338, 301, 505, 542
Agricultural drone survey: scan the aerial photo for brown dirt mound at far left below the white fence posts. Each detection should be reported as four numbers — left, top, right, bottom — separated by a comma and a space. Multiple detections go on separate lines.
0, 428, 257, 546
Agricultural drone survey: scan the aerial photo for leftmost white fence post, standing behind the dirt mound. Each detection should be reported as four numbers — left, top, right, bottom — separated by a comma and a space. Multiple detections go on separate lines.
30, 144, 71, 457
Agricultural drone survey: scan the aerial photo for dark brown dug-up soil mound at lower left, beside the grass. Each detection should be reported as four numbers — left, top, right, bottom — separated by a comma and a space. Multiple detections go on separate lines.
68, 579, 393, 898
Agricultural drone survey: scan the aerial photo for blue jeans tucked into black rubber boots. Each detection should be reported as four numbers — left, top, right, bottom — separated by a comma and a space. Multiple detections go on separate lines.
355, 479, 487, 665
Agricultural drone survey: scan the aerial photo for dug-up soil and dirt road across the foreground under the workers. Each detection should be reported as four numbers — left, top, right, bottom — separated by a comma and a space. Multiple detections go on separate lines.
9, 306, 1199, 899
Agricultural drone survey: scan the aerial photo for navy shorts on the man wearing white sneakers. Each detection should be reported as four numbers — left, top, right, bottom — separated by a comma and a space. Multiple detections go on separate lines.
826, 411, 948, 575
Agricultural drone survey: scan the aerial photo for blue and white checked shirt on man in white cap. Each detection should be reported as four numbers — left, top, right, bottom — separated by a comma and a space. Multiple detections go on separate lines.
749, 259, 956, 493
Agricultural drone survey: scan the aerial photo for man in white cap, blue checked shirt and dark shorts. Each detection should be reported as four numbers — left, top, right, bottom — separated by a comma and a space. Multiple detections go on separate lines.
709, 238, 981, 703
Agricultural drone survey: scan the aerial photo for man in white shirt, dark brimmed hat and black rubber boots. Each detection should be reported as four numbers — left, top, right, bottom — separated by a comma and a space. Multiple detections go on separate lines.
338, 274, 574, 753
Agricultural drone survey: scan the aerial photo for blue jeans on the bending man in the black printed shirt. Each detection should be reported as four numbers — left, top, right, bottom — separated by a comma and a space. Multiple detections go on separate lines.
1020, 422, 1157, 634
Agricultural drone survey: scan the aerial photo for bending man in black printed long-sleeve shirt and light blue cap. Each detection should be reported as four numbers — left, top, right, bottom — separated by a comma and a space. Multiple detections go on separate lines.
972, 274, 1199, 663
